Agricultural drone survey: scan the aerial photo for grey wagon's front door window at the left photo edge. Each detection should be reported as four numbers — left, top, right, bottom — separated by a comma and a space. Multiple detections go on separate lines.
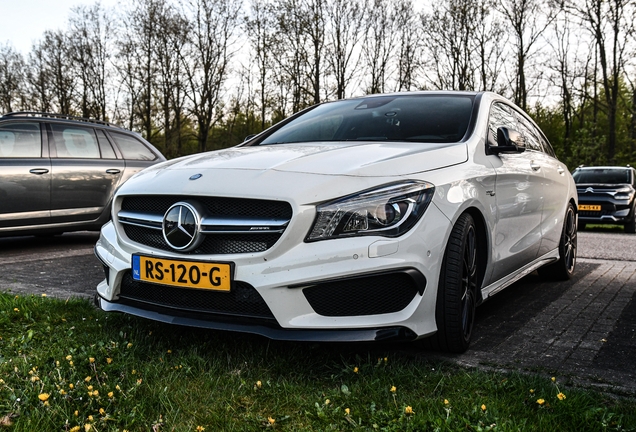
0, 123, 42, 158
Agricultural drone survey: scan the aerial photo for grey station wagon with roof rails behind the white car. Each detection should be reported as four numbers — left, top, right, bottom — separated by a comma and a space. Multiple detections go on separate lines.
0, 112, 165, 237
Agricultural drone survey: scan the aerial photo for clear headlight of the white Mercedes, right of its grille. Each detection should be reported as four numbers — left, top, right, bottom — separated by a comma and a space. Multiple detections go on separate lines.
305, 181, 435, 241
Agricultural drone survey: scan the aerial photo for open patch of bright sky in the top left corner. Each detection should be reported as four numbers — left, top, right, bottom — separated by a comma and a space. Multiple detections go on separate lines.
0, 0, 117, 55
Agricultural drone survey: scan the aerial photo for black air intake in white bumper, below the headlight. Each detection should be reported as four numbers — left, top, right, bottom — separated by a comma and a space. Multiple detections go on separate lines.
303, 272, 422, 316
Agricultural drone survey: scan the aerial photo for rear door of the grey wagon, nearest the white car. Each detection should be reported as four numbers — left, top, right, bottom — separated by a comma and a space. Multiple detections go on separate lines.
49, 123, 125, 223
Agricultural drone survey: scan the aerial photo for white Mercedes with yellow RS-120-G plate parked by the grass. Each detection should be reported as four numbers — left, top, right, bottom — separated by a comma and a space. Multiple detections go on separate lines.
95, 92, 578, 352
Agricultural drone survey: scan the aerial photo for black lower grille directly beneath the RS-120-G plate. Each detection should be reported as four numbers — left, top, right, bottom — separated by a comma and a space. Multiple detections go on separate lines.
119, 272, 275, 321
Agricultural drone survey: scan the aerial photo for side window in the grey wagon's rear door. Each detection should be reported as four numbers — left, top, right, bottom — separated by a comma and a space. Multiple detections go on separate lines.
51, 123, 100, 159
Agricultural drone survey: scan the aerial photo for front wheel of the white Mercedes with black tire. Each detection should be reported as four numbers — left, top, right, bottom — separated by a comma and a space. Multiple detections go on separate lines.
425, 213, 481, 353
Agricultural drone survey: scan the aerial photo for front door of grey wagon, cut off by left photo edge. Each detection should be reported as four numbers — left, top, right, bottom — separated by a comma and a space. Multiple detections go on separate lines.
0, 120, 51, 231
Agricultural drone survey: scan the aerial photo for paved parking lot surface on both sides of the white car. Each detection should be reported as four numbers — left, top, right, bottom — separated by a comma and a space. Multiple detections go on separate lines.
0, 231, 636, 395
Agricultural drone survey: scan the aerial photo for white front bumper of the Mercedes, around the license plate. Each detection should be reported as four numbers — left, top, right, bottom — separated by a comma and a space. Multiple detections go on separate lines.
95, 205, 450, 341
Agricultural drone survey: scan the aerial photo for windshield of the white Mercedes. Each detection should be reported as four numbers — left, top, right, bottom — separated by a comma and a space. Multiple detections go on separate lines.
260, 95, 474, 145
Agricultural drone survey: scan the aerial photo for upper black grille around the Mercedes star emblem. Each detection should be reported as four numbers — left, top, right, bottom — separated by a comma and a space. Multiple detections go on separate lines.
121, 195, 292, 255
